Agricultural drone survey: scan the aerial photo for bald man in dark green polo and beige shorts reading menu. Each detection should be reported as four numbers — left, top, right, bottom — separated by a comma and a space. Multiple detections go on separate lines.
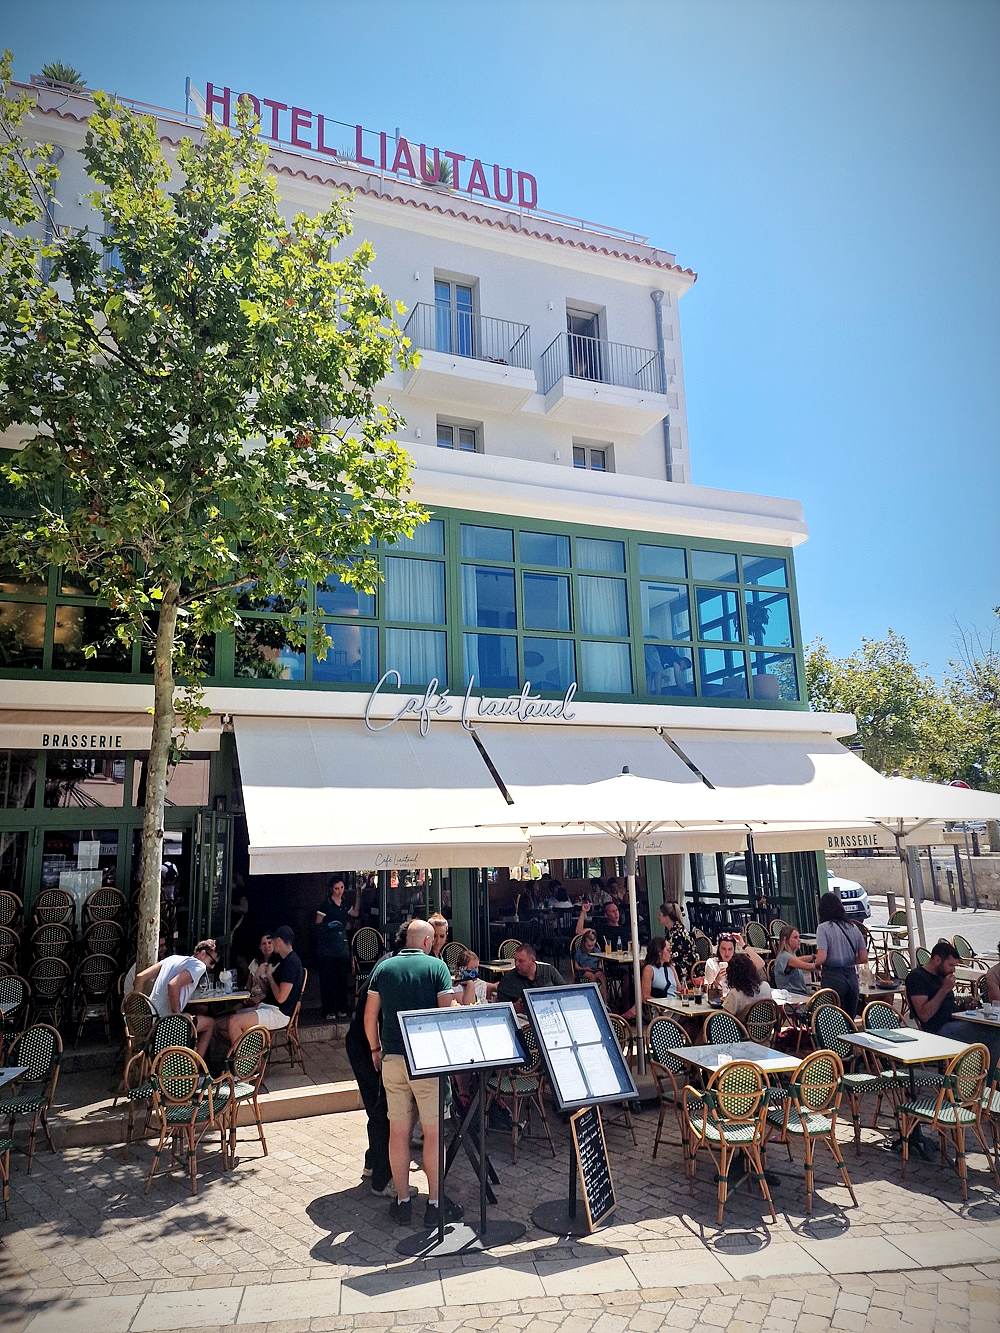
364, 921, 461, 1228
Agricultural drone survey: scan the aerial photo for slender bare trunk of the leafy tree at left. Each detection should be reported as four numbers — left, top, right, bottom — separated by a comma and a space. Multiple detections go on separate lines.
136, 584, 180, 972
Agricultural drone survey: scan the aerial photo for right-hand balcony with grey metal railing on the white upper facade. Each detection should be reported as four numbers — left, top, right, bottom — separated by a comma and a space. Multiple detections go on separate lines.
541, 333, 671, 435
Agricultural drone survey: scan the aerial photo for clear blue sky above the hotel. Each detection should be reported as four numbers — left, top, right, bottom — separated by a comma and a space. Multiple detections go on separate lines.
0, 0, 1000, 674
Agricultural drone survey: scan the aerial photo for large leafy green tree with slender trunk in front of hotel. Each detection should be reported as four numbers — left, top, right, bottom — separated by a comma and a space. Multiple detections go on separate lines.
0, 53, 424, 962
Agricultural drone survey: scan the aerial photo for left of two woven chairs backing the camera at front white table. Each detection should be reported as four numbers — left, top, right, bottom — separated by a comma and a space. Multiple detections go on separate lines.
683, 1060, 777, 1226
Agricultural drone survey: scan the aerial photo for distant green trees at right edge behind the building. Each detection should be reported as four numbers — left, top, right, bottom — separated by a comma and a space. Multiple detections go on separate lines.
805, 629, 1000, 790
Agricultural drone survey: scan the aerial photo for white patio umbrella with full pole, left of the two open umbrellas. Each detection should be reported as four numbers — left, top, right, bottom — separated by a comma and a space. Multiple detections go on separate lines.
434, 766, 776, 1073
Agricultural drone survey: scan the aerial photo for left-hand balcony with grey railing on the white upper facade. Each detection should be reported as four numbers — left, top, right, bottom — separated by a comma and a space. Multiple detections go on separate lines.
403, 303, 539, 412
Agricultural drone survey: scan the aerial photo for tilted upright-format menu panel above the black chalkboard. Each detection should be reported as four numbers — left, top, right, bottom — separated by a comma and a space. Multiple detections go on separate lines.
524, 985, 639, 1110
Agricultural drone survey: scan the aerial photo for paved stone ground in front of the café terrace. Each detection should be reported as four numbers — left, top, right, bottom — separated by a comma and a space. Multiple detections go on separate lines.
0, 1077, 1000, 1333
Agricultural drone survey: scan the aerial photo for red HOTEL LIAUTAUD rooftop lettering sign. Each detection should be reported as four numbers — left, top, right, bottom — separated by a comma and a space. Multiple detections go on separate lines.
205, 84, 539, 208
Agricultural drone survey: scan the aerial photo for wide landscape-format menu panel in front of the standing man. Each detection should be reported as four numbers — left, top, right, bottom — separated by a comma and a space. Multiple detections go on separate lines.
399, 1004, 525, 1078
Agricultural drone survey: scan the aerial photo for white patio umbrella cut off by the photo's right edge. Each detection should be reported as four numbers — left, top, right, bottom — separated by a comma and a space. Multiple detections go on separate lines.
751, 777, 1000, 964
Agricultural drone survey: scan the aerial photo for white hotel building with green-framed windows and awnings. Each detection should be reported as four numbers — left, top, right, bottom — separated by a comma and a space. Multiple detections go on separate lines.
0, 75, 857, 952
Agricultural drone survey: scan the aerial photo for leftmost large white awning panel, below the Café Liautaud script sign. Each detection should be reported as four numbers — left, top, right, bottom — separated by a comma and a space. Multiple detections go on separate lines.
235, 717, 533, 874
